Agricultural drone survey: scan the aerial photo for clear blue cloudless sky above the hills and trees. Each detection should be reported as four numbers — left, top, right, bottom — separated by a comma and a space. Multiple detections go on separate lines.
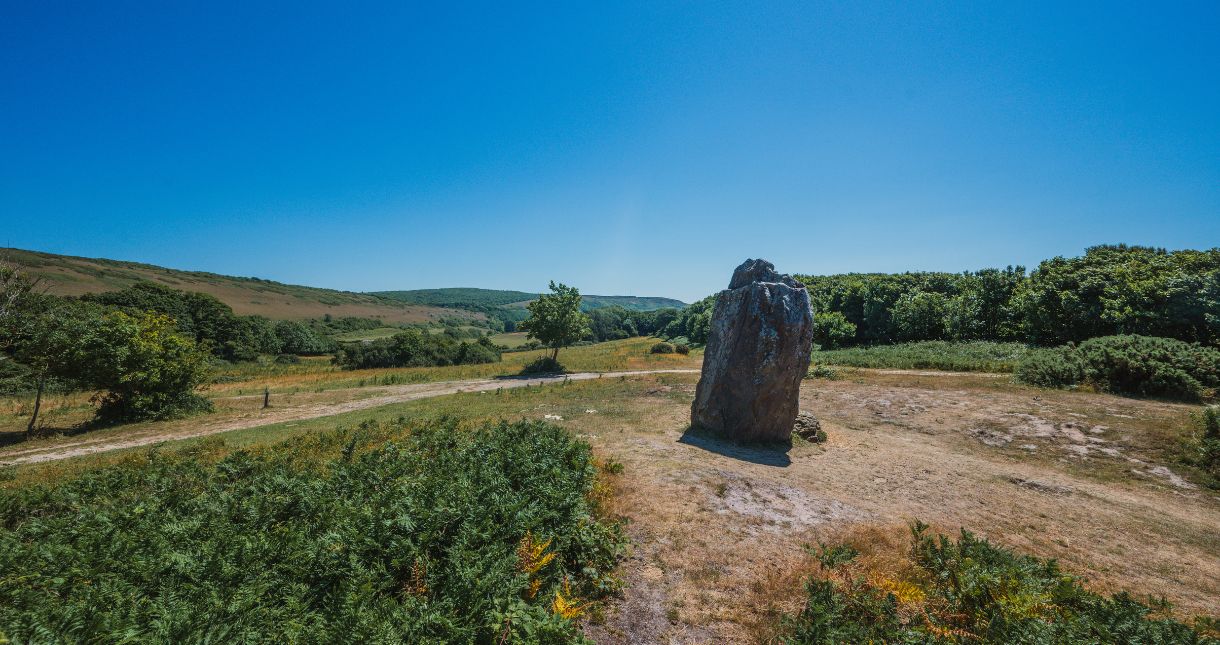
0, 0, 1220, 300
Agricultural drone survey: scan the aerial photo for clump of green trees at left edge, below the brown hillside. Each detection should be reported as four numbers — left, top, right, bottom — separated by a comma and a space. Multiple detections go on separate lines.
0, 273, 334, 433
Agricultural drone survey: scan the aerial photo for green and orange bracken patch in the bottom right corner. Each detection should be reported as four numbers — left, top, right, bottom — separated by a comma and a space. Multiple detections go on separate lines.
782, 523, 1220, 645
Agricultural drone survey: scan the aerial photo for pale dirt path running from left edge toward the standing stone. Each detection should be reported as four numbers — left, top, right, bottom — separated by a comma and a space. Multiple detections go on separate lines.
0, 369, 699, 466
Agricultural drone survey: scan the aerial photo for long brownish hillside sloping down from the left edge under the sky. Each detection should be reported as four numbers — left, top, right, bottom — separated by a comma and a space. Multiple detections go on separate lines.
0, 249, 473, 323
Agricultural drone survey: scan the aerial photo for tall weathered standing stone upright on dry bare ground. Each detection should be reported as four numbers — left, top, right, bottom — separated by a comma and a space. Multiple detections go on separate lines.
691, 260, 814, 441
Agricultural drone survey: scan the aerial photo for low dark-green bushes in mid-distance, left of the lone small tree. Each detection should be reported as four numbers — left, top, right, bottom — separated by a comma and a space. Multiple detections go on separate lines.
334, 329, 501, 369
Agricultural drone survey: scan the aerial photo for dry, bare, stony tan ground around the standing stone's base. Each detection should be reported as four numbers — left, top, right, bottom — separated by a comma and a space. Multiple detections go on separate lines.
575, 372, 1220, 643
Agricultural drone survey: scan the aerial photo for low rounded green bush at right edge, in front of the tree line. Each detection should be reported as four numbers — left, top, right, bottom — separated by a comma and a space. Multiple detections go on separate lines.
1016, 335, 1220, 400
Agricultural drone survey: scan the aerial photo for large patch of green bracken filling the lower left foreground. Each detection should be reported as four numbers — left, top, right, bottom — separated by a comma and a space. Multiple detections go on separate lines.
0, 422, 623, 644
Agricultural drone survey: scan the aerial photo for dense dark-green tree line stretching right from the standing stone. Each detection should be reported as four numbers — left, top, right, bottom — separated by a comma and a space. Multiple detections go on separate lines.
798, 245, 1220, 347
